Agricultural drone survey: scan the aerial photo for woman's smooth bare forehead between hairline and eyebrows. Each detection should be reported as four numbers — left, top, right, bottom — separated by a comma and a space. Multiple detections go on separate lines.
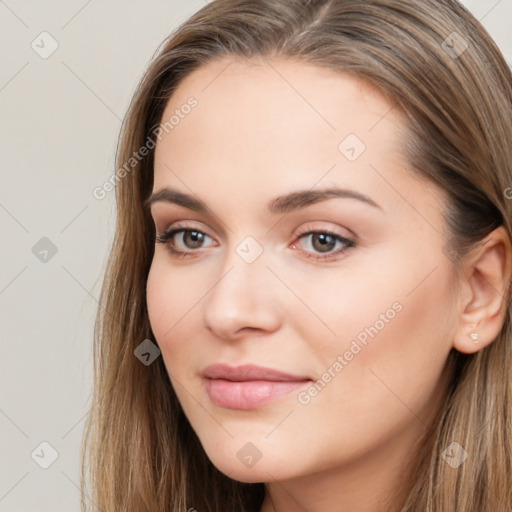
154, 57, 440, 219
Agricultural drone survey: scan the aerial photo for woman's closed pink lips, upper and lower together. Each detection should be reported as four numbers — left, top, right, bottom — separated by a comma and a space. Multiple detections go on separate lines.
201, 364, 312, 409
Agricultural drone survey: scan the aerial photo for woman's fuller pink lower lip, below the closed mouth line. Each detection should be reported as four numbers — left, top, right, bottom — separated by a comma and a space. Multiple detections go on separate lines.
205, 379, 311, 409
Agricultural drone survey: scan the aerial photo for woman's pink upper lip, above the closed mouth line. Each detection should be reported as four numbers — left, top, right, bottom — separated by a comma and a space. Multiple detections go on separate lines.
201, 363, 311, 382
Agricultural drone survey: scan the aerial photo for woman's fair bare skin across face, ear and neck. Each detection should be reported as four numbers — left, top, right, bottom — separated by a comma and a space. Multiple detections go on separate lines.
147, 58, 511, 512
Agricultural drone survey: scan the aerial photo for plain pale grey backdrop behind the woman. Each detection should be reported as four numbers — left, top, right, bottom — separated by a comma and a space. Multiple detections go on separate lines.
0, 0, 512, 512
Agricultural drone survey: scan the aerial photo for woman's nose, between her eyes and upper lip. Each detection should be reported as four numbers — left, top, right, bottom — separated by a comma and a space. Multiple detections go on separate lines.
203, 249, 281, 340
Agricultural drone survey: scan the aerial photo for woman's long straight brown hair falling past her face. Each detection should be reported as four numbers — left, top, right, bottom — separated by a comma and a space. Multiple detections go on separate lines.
82, 0, 512, 512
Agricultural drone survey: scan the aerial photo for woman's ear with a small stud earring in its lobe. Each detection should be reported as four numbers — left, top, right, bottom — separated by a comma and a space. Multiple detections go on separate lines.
453, 226, 512, 354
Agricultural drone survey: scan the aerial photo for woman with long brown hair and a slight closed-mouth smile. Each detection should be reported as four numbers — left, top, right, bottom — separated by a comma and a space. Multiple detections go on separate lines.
83, 0, 512, 512
